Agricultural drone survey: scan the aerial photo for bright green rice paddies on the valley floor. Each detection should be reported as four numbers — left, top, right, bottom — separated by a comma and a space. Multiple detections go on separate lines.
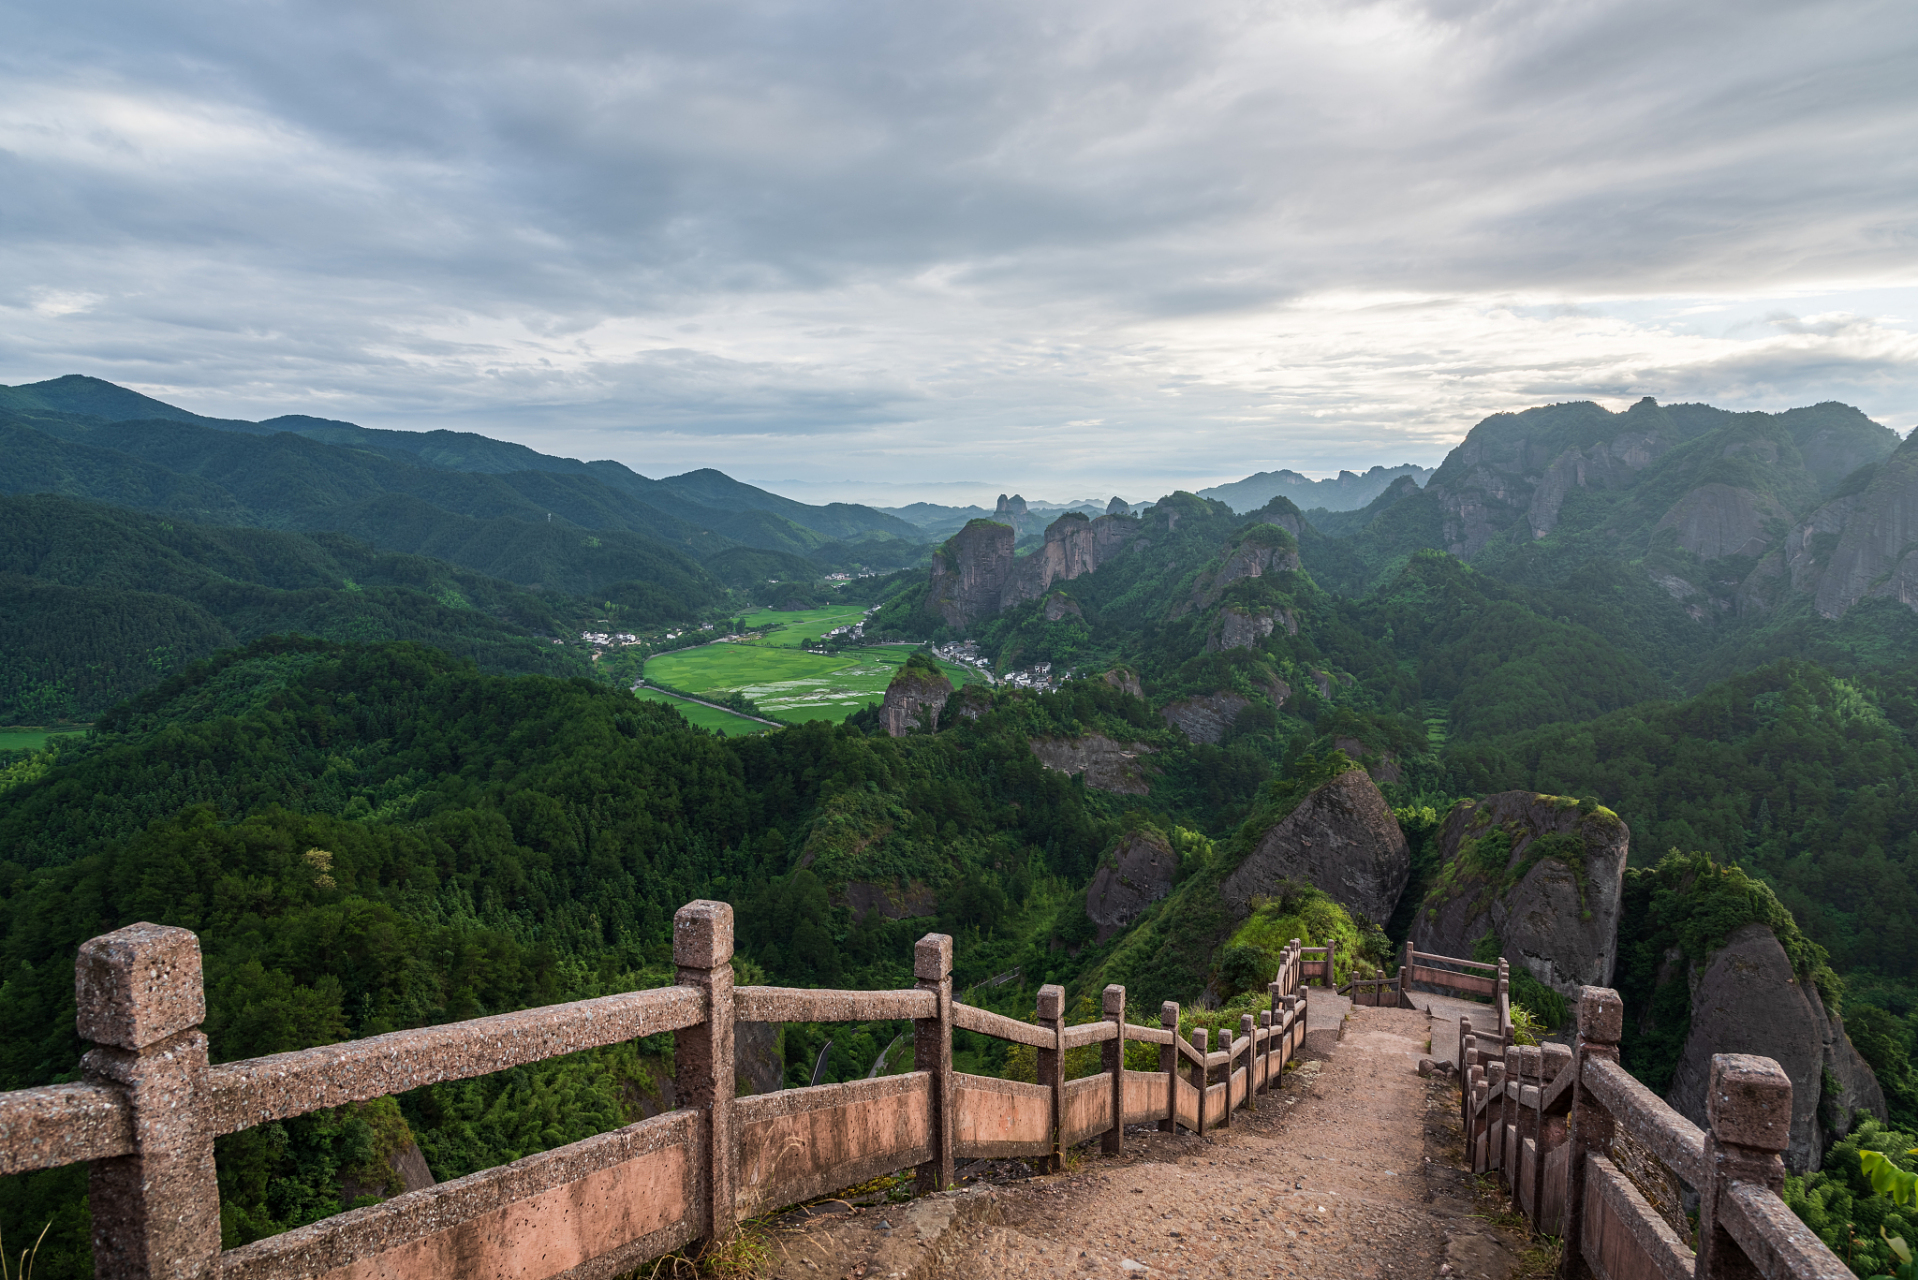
646, 606, 978, 733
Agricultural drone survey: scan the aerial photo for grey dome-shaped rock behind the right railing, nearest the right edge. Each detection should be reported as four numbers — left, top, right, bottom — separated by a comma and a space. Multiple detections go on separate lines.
1667, 923, 1885, 1173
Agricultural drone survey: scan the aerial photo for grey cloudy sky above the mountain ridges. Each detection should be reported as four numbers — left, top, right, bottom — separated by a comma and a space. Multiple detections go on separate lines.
0, 0, 1918, 501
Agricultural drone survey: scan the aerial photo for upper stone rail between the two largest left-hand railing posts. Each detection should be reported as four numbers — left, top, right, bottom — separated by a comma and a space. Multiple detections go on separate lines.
203, 986, 705, 1134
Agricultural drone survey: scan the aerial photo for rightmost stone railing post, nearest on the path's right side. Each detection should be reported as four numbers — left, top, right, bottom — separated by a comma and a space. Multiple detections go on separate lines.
1697, 1054, 1791, 1280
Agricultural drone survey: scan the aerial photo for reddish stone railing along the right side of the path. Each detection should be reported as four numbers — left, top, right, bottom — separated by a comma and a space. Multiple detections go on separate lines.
1460, 986, 1851, 1280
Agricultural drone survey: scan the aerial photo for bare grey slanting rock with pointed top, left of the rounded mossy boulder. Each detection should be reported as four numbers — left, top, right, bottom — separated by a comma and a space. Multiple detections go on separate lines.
1220, 770, 1412, 925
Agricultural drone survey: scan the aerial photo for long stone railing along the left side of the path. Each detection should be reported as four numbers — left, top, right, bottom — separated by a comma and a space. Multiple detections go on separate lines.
0, 902, 1331, 1280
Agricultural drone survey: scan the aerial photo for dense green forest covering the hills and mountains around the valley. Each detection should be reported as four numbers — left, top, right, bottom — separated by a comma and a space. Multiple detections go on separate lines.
0, 380, 1918, 1278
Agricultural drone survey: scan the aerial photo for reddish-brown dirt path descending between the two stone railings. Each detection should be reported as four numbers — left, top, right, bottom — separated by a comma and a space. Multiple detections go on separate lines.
773, 1007, 1523, 1280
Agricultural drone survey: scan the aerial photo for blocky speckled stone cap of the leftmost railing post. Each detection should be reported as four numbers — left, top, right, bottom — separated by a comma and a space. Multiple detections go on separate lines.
73, 923, 207, 1050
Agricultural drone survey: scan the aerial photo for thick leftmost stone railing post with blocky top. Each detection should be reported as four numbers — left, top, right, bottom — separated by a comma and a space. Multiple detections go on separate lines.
73, 923, 221, 1280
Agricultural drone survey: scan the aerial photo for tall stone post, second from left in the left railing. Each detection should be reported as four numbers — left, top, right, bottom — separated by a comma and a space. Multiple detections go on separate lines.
673, 900, 738, 1242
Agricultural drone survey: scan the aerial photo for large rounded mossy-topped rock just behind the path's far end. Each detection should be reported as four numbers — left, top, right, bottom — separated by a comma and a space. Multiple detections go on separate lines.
1412, 791, 1632, 996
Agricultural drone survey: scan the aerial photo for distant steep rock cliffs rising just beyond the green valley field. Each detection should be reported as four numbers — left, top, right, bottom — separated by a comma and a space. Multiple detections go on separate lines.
926, 512, 1141, 629
